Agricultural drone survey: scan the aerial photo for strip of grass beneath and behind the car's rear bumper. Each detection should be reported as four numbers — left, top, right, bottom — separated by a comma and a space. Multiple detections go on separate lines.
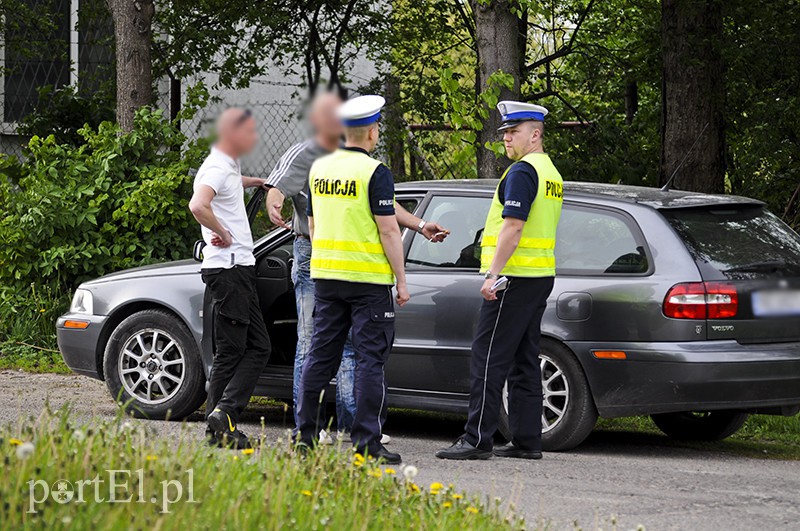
595, 415, 800, 460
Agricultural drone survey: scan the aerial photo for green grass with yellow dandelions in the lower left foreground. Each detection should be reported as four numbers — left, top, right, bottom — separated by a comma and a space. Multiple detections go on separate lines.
0, 409, 524, 530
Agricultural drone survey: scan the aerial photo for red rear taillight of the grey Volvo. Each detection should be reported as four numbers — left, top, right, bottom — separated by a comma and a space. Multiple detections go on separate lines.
664, 282, 739, 319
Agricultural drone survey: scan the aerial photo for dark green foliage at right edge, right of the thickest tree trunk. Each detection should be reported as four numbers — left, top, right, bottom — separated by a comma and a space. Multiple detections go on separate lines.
723, 0, 800, 230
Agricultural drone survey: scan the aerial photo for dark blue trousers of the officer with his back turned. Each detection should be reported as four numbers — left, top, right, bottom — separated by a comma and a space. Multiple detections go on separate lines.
297, 280, 394, 453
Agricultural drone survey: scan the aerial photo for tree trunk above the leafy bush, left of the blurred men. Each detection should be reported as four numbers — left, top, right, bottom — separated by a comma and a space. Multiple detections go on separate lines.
107, 0, 155, 132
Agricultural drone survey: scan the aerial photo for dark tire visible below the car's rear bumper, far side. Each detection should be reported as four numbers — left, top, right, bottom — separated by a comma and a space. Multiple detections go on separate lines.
651, 411, 748, 441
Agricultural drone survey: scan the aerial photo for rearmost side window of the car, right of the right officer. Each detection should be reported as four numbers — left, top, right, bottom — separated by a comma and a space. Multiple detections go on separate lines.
556, 204, 649, 275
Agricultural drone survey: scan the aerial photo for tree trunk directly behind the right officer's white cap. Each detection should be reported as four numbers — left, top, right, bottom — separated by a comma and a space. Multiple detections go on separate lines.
472, 0, 525, 179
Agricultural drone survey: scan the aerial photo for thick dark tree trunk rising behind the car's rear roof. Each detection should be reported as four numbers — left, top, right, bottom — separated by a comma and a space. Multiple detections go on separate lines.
659, 0, 725, 193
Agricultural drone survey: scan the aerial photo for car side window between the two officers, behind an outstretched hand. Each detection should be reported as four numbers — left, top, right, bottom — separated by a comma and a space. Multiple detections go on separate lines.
406, 195, 491, 269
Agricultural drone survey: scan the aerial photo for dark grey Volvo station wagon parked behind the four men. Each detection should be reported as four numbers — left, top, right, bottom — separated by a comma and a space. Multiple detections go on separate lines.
58, 181, 800, 450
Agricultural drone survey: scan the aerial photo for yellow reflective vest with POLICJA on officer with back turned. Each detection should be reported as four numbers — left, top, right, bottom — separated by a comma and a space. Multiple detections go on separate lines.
309, 149, 394, 285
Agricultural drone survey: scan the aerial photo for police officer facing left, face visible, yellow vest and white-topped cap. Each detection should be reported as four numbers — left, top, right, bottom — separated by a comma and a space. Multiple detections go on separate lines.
436, 101, 562, 459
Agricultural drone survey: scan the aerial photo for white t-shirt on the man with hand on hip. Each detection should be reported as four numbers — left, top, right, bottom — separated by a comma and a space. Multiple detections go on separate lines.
194, 147, 256, 269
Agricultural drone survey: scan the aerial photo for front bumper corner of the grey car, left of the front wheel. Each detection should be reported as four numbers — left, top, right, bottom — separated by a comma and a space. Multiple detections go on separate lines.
56, 314, 107, 380
